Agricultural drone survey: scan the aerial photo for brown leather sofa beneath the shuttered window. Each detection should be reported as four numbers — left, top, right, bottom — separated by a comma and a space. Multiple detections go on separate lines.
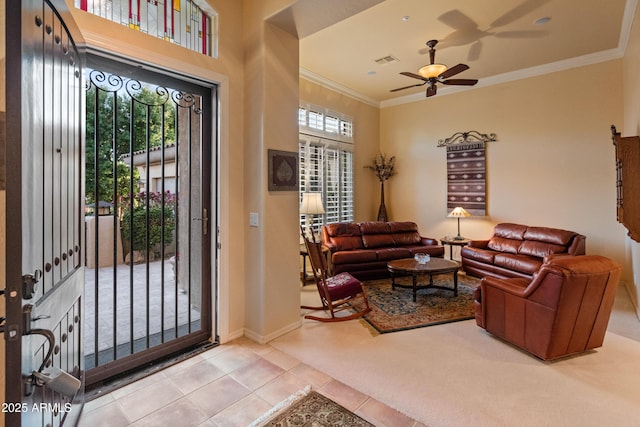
322, 221, 444, 280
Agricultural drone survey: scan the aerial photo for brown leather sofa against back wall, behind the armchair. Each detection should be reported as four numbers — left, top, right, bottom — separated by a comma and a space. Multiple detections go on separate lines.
460, 223, 586, 279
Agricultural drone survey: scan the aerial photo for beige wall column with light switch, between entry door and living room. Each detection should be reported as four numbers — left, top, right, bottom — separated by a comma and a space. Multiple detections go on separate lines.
242, 0, 300, 342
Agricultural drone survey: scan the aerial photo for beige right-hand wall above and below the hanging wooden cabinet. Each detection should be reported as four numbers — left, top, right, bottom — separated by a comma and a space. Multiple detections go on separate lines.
617, 1, 640, 316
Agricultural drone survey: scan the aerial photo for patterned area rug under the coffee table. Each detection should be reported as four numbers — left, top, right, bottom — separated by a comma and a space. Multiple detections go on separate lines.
354, 274, 480, 334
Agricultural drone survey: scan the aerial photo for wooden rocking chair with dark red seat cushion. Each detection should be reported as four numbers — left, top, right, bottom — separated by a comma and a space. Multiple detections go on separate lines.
300, 227, 371, 322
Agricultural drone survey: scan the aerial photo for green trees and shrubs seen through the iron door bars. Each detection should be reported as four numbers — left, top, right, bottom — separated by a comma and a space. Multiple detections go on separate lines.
85, 70, 176, 260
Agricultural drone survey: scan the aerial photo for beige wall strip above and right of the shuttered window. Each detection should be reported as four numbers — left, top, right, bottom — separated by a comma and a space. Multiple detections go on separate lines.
300, 79, 380, 221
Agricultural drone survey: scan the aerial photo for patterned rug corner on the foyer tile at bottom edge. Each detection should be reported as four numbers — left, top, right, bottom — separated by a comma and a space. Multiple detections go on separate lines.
250, 386, 375, 427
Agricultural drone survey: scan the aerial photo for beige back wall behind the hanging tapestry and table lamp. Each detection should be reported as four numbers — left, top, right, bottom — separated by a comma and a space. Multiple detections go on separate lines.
380, 60, 630, 279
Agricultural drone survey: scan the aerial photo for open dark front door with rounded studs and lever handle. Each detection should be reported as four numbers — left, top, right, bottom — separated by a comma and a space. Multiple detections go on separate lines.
2, 0, 84, 426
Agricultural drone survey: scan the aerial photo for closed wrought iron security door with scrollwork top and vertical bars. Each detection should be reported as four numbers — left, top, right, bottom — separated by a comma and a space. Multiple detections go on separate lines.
85, 57, 216, 385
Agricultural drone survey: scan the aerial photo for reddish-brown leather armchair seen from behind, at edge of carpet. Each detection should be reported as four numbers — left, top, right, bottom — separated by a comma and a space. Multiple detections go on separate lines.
475, 255, 622, 360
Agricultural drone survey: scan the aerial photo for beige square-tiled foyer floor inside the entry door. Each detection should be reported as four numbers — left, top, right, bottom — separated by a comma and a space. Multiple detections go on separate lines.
79, 338, 423, 427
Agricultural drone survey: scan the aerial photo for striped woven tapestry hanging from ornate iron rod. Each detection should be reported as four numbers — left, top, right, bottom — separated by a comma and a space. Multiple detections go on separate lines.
438, 131, 495, 216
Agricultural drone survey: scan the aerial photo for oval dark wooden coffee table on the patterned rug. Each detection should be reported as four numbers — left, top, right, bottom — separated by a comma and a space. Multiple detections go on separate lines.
387, 258, 460, 302
